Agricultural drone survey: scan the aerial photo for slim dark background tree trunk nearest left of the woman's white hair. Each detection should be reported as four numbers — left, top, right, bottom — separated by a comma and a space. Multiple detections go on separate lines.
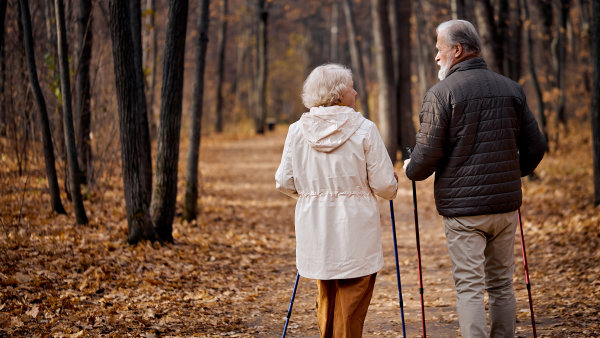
254, 0, 269, 134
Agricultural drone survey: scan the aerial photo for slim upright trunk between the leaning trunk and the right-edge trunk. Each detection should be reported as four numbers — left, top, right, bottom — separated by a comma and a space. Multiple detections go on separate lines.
556, 0, 570, 126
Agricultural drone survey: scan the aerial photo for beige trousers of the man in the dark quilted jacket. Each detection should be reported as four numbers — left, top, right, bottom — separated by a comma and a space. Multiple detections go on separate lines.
444, 211, 518, 338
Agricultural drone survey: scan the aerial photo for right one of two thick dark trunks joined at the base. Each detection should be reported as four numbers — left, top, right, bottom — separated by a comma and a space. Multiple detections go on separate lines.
150, 0, 188, 243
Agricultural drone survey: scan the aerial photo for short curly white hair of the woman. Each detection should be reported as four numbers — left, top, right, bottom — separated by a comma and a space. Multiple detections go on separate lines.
302, 63, 352, 109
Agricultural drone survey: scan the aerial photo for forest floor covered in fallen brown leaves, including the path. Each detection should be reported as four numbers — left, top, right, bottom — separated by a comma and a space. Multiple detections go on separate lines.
0, 123, 600, 337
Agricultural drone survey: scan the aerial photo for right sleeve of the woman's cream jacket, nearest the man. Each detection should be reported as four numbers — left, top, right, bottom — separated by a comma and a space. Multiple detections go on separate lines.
365, 124, 398, 200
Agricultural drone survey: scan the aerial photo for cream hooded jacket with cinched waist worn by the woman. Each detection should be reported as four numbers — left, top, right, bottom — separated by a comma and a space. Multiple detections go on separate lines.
275, 106, 398, 280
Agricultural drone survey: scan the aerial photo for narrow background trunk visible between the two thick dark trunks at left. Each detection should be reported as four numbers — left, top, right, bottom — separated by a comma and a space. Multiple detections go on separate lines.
143, 0, 158, 139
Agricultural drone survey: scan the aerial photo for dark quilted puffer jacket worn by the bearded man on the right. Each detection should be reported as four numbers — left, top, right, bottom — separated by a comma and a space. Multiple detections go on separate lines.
406, 58, 546, 217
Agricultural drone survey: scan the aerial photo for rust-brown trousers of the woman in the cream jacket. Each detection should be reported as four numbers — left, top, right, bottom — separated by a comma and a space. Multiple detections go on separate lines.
317, 273, 377, 338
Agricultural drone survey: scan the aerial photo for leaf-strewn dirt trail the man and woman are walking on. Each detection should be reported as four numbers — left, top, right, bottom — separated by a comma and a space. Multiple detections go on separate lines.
202, 128, 546, 337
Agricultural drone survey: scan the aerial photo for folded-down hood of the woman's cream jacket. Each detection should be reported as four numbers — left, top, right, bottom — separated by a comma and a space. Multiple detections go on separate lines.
300, 106, 365, 153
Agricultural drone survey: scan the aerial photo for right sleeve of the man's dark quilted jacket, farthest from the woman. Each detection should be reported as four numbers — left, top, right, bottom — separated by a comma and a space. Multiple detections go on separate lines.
518, 94, 547, 176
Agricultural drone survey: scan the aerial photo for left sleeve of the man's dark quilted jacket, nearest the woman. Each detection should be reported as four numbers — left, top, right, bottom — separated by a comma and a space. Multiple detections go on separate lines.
406, 91, 449, 181
